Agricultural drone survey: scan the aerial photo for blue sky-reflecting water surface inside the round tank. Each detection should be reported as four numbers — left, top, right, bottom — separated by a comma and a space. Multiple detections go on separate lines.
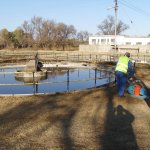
0, 68, 114, 94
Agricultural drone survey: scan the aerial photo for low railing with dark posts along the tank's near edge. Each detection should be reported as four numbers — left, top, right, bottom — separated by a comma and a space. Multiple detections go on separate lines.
0, 68, 114, 95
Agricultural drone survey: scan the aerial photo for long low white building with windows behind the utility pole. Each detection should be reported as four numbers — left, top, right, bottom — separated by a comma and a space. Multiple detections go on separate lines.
89, 35, 150, 46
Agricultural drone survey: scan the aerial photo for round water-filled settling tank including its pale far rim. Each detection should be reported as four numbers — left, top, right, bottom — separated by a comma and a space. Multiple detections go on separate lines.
0, 64, 114, 95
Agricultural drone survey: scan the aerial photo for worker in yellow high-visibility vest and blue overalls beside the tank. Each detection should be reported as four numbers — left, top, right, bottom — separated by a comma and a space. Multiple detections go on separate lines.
115, 52, 134, 97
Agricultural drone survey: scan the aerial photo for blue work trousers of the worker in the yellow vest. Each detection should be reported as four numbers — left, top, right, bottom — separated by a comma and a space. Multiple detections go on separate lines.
116, 71, 127, 96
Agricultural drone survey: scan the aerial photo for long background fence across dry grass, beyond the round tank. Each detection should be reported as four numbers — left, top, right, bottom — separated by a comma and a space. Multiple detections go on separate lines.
0, 51, 150, 63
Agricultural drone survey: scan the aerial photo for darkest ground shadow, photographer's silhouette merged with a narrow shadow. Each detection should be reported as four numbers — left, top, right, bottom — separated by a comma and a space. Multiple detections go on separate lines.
101, 88, 139, 150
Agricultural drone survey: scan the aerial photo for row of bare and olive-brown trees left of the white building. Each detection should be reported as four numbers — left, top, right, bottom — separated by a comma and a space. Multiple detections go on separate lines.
0, 17, 89, 50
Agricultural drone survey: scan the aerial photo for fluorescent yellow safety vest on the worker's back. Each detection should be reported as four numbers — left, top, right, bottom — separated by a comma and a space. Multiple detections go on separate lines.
115, 56, 130, 74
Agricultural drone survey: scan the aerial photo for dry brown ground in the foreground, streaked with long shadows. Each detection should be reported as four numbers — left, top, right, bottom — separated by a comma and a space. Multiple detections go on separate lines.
0, 65, 150, 150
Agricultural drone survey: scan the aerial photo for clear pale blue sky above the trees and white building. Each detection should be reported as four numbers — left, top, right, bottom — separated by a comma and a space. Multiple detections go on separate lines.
0, 0, 150, 36
